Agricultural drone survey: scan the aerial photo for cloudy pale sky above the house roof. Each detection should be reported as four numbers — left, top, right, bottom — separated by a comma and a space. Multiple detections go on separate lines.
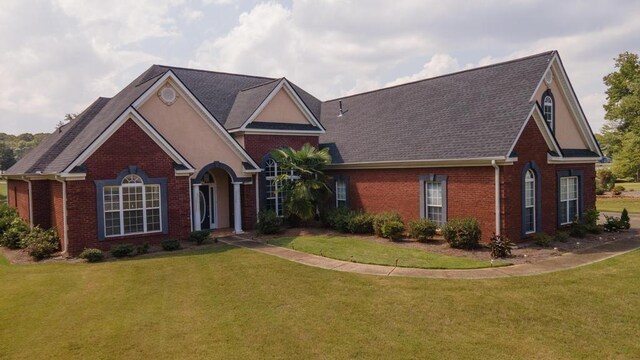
0, 0, 640, 134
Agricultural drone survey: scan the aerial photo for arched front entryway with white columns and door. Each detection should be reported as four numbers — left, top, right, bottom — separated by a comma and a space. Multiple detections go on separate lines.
191, 161, 251, 233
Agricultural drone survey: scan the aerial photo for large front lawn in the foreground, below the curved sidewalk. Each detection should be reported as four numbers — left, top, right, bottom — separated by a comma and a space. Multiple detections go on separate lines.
0, 247, 640, 359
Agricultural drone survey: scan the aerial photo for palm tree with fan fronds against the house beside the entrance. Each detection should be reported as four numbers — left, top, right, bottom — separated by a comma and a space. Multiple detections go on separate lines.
271, 143, 331, 222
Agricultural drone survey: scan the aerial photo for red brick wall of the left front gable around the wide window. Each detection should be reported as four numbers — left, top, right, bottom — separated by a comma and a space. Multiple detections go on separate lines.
67, 120, 191, 255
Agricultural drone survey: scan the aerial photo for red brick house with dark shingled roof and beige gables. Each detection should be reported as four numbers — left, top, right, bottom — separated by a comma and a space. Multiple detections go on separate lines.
3, 51, 601, 255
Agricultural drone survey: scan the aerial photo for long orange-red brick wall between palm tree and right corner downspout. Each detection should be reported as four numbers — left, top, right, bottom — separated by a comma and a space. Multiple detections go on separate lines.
328, 166, 495, 241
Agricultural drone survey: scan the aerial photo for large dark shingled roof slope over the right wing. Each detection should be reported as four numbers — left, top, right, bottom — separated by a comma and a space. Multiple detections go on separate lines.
320, 51, 555, 164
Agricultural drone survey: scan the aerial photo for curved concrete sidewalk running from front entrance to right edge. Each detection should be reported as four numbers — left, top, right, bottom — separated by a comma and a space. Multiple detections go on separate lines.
219, 235, 640, 279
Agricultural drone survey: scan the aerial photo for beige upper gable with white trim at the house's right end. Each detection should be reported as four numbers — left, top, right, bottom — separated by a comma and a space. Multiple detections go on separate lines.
531, 53, 602, 156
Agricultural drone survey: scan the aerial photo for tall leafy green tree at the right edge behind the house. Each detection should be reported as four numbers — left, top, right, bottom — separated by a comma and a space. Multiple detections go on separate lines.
598, 52, 640, 180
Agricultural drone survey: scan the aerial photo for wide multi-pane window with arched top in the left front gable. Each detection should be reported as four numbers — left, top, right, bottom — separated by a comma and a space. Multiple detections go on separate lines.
103, 174, 162, 236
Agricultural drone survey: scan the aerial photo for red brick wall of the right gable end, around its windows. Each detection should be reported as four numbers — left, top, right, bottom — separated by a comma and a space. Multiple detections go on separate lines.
501, 118, 595, 241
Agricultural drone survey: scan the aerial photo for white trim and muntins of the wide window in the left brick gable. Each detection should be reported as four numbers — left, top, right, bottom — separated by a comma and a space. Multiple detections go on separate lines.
102, 175, 162, 239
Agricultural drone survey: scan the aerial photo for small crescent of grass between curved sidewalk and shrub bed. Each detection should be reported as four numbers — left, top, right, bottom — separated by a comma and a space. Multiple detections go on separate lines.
269, 236, 508, 269
